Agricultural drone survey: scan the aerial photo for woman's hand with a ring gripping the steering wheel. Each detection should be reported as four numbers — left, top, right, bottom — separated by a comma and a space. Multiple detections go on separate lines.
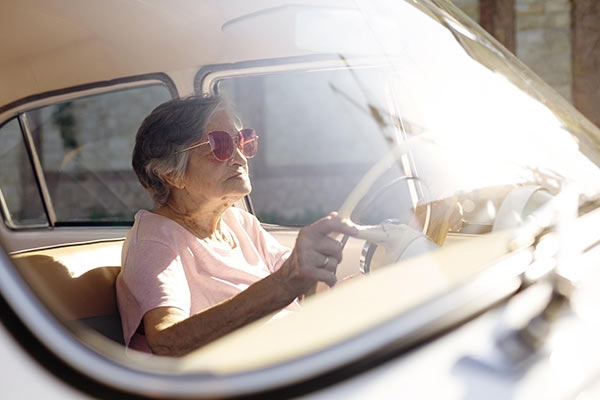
274, 212, 358, 296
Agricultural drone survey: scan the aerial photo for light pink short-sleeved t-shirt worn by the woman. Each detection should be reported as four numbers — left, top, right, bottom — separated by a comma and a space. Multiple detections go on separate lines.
117, 207, 298, 352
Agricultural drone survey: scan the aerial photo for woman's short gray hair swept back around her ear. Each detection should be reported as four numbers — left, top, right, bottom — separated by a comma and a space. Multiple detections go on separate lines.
132, 95, 230, 205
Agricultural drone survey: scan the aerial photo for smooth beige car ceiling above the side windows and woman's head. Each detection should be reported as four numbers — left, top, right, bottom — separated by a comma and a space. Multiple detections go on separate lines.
0, 0, 322, 112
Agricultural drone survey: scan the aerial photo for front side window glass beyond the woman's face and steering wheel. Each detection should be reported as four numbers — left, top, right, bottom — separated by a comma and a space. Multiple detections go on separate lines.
218, 68, 411, 225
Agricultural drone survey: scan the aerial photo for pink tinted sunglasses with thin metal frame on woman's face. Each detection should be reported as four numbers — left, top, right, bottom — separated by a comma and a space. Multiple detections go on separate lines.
177, 128, 258, 161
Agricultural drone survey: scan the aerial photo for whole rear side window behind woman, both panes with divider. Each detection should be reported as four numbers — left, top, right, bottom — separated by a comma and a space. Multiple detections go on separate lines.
0, 81, 171, 229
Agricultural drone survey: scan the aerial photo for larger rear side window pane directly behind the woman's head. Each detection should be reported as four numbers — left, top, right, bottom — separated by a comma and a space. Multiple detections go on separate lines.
27, 85, 171, 225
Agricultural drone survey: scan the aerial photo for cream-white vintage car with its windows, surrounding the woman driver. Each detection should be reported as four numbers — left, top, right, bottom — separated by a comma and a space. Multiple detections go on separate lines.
0, 0, 600, 399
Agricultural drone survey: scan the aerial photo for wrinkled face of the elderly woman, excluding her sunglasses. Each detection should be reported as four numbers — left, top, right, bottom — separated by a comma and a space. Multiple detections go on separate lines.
183, 111, 252, 209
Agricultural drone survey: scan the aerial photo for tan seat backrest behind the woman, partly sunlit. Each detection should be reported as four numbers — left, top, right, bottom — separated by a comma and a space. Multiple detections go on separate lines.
12, 240, 123, 343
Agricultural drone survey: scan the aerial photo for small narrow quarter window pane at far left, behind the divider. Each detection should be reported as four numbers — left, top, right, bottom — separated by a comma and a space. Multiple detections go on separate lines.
0, 118, 48, 228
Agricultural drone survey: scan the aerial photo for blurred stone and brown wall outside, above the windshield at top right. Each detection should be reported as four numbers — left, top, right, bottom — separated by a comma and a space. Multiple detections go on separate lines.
452, 0, 600, 126
